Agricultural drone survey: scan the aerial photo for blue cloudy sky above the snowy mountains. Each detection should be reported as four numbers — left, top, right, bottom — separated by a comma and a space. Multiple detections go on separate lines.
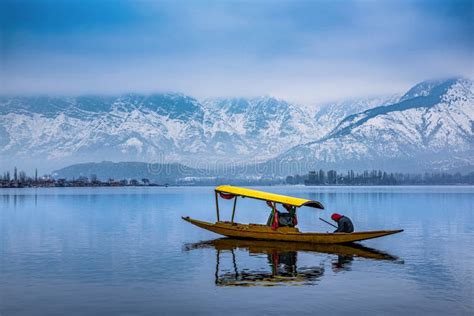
0, 0, 474, 103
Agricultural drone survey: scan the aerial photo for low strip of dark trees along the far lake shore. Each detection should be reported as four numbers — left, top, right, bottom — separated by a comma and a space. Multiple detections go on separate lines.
0, 167, 474, 188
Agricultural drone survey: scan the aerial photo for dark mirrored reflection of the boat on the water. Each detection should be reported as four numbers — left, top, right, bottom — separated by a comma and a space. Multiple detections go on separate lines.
184, 238, 403, 286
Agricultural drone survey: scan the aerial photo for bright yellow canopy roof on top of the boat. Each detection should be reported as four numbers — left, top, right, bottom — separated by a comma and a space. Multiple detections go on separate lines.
215, 185, 324, 210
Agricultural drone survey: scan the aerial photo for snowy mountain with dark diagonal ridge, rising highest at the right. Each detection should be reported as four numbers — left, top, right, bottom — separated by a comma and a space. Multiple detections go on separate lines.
273, 79, 474, 172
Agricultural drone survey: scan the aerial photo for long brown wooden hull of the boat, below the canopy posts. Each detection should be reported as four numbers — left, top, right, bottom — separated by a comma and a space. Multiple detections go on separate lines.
182, 217, 403, 244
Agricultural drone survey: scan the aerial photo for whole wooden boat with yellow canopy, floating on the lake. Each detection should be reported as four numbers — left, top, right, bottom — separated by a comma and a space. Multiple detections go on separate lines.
182, 185, 403, 244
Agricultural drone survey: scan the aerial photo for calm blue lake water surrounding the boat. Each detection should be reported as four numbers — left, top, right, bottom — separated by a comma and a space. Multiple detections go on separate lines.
0, 187, 474, 316
